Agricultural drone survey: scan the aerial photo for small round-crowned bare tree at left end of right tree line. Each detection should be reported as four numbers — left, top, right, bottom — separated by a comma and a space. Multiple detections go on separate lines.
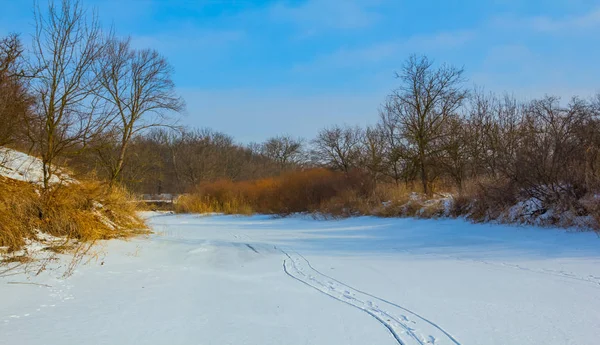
313, 126, 362, 173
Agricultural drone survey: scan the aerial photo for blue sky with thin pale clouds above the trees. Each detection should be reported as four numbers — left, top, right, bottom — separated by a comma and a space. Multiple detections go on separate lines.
0, 0, 600, 142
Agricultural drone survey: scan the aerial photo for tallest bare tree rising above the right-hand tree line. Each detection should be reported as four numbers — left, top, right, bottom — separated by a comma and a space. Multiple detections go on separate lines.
387, 56, 468, 193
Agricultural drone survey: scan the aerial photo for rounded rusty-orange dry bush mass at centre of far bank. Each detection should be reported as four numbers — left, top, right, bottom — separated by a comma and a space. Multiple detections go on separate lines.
176, 169, 372, 215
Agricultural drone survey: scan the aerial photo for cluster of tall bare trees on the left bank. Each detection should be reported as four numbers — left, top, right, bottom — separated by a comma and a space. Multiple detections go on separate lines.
0, 0, 184, 189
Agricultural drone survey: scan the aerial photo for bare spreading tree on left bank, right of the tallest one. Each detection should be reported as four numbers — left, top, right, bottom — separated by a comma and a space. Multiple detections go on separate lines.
96, 37, 184, 184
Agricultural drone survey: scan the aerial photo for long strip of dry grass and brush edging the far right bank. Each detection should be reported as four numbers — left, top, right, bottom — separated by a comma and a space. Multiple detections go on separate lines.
176, 169, 600, 228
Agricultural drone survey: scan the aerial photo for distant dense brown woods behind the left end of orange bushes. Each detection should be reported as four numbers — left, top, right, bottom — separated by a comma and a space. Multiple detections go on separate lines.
92, 128, 300, 193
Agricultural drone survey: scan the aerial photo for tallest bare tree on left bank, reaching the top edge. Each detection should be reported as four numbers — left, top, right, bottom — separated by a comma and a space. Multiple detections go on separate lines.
25, 0, 106, 189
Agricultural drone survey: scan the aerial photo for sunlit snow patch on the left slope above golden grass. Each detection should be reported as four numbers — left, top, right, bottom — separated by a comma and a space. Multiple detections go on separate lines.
0, 147, 72, 184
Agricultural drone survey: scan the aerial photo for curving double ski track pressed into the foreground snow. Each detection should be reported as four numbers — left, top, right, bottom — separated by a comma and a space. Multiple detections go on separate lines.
280, 249, 460, 345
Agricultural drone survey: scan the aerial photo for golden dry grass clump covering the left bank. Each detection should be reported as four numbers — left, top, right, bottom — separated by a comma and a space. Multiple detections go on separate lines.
0, 177, 147, 253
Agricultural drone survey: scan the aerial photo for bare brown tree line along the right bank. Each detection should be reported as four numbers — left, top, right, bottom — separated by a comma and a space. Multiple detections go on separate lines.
314, 56, 600, 211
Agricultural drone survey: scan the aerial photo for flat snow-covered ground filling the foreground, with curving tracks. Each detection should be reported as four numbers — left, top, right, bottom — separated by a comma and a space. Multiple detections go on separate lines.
0, 214, 600, 345
